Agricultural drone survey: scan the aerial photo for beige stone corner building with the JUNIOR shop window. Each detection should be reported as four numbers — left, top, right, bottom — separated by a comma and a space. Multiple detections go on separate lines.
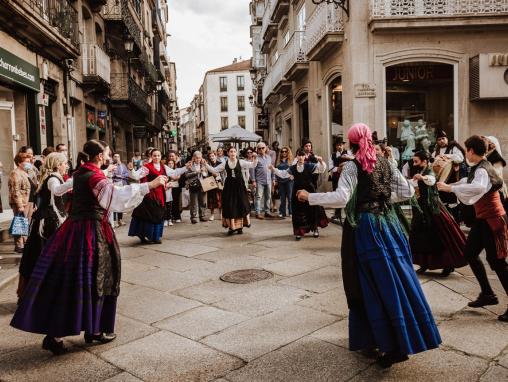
251, 0, 508, 182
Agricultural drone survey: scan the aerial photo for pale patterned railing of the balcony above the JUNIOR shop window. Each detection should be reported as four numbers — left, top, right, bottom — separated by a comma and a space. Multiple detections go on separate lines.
370, 0, 508, 19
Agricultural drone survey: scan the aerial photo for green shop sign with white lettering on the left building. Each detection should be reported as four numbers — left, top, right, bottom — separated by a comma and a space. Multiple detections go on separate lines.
0, 48, 40, 92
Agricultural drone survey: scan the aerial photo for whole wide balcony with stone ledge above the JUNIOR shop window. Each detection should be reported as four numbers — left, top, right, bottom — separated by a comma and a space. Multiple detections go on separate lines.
370, 0, 508, 31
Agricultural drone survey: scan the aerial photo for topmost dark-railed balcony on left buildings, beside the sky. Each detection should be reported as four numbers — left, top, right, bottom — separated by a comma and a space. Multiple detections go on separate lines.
102, 0, 143, 50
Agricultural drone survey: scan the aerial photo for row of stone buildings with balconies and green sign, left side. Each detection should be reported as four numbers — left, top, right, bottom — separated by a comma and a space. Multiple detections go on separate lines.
0, 0, 176, 182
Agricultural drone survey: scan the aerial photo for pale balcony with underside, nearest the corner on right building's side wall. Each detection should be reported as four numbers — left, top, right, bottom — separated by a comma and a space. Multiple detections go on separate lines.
303, 3, 344, 61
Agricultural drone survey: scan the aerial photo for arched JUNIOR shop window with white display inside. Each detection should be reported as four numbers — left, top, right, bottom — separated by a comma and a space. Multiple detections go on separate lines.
386, 62, 454, 164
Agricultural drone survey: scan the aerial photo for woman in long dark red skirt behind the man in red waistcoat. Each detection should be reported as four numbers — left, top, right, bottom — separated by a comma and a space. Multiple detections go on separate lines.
409, 151, 467, 277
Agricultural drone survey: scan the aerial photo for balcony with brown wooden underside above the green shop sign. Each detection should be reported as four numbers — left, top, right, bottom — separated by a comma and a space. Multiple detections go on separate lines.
0, 0, 80, 61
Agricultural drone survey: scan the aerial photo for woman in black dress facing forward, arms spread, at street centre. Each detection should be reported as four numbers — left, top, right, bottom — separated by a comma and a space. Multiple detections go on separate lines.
208, 147, 258, 235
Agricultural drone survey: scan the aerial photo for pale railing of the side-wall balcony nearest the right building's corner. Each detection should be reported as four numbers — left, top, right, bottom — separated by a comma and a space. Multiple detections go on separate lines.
303, 3, 344, 54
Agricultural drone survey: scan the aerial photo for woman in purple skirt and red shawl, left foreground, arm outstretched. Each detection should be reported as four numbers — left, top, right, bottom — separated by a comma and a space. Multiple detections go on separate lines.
11, 140, 166, 354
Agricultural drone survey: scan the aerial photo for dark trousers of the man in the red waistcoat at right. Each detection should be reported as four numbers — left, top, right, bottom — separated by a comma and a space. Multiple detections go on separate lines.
464, 216, 508, 295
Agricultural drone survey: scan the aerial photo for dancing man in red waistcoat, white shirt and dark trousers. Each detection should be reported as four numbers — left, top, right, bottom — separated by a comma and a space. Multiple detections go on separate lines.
437, 135, 508, 322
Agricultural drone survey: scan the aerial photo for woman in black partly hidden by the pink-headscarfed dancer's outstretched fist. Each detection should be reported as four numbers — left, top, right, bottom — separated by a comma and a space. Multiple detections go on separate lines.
271, 149, 328, 240
